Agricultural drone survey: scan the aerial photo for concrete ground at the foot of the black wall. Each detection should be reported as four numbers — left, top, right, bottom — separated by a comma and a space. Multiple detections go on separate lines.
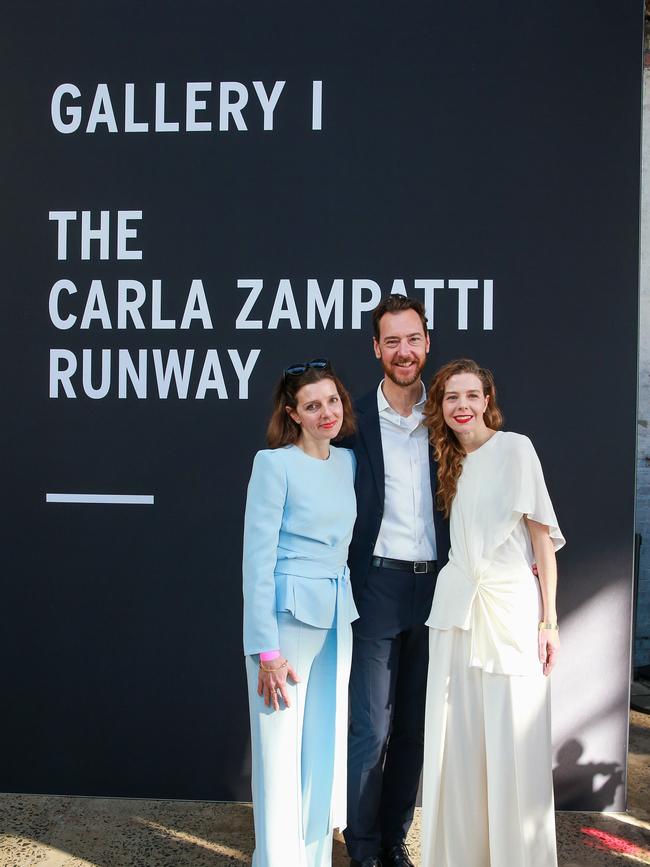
0, 708, 650, 867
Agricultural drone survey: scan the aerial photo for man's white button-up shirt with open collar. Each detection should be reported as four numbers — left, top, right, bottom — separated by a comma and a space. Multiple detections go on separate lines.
373, 383, 436, 560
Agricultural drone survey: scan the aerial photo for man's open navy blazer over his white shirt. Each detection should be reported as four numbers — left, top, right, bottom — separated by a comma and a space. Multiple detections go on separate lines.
342, 388, 449, 599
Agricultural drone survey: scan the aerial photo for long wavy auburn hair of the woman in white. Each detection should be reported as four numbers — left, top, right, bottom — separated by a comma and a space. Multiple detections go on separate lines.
424, 358, 503, 518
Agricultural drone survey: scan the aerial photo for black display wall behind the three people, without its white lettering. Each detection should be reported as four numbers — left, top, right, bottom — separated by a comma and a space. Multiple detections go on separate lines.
0, 0, 642, 809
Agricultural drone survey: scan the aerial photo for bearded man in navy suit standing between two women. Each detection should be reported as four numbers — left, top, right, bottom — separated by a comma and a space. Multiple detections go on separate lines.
345, 295, 449, 867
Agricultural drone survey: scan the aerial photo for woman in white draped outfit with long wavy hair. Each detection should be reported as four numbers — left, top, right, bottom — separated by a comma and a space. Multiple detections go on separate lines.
422, 359, 564, 867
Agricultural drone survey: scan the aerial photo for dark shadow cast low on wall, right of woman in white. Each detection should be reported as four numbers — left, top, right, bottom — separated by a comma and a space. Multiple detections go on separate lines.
553, 738, 624, 811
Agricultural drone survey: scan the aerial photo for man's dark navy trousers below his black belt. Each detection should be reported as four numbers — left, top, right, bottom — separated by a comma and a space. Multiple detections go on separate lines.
344, 568, 435, 861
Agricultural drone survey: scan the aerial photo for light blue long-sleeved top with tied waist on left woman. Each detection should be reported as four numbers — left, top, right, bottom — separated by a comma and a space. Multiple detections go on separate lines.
243, 445, 359, 655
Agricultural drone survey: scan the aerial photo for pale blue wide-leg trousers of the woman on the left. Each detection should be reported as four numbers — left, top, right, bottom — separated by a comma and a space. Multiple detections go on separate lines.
246, 612, 337, 867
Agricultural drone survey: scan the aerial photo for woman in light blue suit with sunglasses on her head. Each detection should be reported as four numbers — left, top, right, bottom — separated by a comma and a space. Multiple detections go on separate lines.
243, 359, 358, 867
